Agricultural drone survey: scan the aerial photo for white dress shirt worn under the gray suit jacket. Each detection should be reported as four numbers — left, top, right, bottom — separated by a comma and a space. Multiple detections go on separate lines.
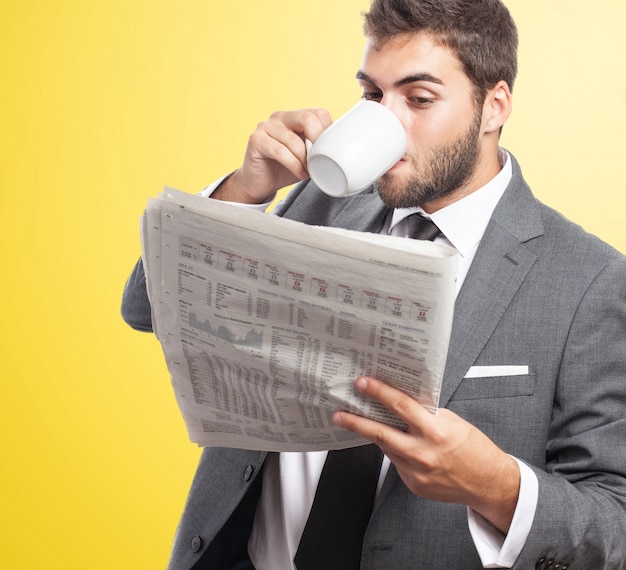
201, 151, 538, 570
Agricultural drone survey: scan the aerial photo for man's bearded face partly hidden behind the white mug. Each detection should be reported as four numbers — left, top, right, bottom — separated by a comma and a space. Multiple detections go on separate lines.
357, 34, 486, 212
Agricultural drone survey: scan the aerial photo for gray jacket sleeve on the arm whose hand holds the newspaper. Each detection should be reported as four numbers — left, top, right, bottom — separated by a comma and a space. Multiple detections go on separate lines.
514, 255, 626, 570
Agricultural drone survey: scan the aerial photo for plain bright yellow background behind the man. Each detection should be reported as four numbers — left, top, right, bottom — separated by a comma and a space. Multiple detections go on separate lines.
0, 0, 626, 570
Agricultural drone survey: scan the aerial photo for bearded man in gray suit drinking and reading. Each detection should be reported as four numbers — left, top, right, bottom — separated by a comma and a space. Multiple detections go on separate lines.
123, 0, 626, 570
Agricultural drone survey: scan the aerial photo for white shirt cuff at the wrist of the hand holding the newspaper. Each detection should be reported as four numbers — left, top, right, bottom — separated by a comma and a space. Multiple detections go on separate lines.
467, 457, 539, 568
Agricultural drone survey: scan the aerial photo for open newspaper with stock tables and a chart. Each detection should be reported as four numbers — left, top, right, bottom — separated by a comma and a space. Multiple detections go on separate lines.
142, 188, 457, 451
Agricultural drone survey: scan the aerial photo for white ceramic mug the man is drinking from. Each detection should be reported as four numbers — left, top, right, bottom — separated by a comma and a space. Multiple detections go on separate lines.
307, 101, 406, 197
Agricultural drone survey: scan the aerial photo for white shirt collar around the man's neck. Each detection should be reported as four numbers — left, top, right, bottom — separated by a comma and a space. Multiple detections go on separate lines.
389, 150, 513, 256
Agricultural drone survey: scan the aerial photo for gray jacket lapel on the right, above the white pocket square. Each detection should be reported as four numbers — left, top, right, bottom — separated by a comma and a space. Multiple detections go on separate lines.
439, 154, 543, 407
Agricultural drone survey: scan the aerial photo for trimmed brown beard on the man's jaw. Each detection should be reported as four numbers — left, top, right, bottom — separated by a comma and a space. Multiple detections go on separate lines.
375, 108, 482, 208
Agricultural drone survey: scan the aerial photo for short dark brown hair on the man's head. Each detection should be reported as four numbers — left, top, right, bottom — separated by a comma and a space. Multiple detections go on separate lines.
363, 0, 518, 100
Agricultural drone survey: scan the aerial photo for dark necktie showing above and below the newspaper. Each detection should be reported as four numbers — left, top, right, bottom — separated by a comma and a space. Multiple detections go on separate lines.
294, 214, 442, 570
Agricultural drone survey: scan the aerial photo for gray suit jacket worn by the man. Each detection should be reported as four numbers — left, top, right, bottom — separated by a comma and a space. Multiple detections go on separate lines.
123, 153, 626, 570
